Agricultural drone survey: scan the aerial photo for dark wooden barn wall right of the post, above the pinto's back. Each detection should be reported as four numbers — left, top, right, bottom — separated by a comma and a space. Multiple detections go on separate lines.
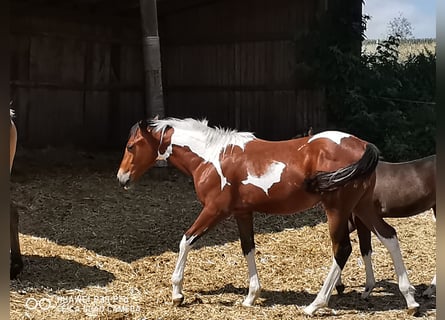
159, 0, 326, 140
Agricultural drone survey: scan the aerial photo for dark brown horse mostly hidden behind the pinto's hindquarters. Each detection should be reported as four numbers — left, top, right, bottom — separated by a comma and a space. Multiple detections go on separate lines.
337, 155, 436, 298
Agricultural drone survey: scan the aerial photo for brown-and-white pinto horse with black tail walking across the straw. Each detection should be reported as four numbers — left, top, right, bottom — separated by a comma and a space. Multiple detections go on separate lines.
117, 118, 419, 315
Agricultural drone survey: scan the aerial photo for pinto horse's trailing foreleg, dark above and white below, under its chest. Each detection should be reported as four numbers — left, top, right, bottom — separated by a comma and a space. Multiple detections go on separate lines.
235, 212, 261, 307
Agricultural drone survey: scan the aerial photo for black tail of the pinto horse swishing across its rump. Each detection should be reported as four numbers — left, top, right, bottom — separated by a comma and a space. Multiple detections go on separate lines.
305, 143, 380, 192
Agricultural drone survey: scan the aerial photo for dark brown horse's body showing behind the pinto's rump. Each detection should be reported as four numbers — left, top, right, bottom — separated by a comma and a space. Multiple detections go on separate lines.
374, 155, 436, 217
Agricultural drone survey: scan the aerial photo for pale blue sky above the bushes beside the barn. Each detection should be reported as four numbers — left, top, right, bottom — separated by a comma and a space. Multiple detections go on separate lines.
363, 0, 436, 39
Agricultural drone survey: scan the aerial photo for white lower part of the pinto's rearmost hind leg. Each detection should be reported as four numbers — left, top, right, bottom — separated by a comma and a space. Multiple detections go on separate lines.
376, 232, 419, 309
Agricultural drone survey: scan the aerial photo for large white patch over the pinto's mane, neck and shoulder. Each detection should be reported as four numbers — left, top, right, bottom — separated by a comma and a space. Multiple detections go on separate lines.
152, 118, 256, 190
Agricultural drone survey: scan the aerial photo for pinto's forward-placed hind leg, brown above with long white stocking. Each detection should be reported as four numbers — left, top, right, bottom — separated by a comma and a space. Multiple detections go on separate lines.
303, 210, 352, 316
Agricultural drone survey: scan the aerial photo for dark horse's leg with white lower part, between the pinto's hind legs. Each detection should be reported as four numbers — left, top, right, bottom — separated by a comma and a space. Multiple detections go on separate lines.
355, 218, 375, 299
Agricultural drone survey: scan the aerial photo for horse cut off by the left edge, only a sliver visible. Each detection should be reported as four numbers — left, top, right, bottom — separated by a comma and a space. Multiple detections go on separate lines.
9, 109, 23, 279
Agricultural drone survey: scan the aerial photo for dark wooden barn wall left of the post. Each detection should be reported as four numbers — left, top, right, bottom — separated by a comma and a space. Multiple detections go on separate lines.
10, 10, 145, 148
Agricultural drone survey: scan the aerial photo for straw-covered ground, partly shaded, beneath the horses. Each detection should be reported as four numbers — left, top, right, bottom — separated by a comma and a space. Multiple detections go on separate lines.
10, 151, 436, 320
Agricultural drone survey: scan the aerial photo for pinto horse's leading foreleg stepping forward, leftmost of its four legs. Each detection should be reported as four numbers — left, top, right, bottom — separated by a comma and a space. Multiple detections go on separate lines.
171, 208, 226, 306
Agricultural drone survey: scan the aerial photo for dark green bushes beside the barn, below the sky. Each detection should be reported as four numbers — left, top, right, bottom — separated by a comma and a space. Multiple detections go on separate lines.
318, 36, 436, 161
